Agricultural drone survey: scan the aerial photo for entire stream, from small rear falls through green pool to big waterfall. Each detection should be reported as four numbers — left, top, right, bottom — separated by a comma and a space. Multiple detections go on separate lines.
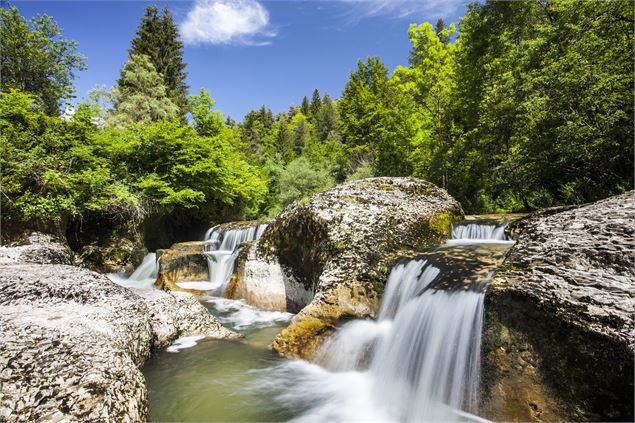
143, 222, 512, 423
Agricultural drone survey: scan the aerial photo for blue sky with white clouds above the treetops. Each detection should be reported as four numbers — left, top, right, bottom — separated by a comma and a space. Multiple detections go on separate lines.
12, 0, 465, 120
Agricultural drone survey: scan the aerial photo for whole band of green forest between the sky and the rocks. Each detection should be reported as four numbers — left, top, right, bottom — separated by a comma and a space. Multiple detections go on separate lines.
0, 0, 635, 249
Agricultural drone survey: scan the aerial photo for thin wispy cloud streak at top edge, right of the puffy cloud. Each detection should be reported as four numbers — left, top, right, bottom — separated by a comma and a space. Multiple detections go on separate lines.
340, 0, 467, 19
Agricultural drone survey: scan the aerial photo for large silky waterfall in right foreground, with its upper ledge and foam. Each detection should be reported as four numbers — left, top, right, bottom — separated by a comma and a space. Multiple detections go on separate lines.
263, 223, 509, 422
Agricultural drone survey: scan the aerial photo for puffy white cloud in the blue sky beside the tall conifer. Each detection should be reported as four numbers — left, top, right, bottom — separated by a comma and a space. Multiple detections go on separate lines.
180, 0, 276, 45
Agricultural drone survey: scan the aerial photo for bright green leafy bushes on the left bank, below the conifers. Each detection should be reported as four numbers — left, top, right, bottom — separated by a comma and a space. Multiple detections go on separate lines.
0, 90, 266, 240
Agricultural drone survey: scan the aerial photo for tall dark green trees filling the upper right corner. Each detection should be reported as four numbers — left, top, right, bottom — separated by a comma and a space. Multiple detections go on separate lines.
450, 1, 634, 209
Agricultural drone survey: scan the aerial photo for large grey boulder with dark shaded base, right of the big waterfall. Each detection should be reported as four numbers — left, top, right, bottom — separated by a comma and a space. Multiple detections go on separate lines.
482, 191, 635, 421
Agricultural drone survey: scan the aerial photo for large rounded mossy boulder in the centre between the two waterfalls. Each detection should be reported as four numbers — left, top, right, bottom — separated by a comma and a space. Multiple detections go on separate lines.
228, 178, 463, 358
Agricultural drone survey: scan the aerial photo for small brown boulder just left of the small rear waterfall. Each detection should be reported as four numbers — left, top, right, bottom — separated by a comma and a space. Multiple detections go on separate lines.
155, 241, 209, 294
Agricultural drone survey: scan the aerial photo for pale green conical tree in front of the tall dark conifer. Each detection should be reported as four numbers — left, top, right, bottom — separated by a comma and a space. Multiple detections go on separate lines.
107, 54, 179, 126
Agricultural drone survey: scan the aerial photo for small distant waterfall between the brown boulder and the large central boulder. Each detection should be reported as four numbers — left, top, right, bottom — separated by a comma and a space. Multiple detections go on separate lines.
204, 223, 267, 295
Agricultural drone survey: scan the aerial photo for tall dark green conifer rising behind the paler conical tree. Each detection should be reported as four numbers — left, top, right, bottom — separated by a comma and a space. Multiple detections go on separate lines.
130, 6, 189, 117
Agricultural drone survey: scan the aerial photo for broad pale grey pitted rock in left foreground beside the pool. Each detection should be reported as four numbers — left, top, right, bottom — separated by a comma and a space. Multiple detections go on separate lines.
0, 234, 237, 422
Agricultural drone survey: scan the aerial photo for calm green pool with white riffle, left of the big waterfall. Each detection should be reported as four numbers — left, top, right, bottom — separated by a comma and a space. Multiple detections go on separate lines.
142, 298, 292, 422
